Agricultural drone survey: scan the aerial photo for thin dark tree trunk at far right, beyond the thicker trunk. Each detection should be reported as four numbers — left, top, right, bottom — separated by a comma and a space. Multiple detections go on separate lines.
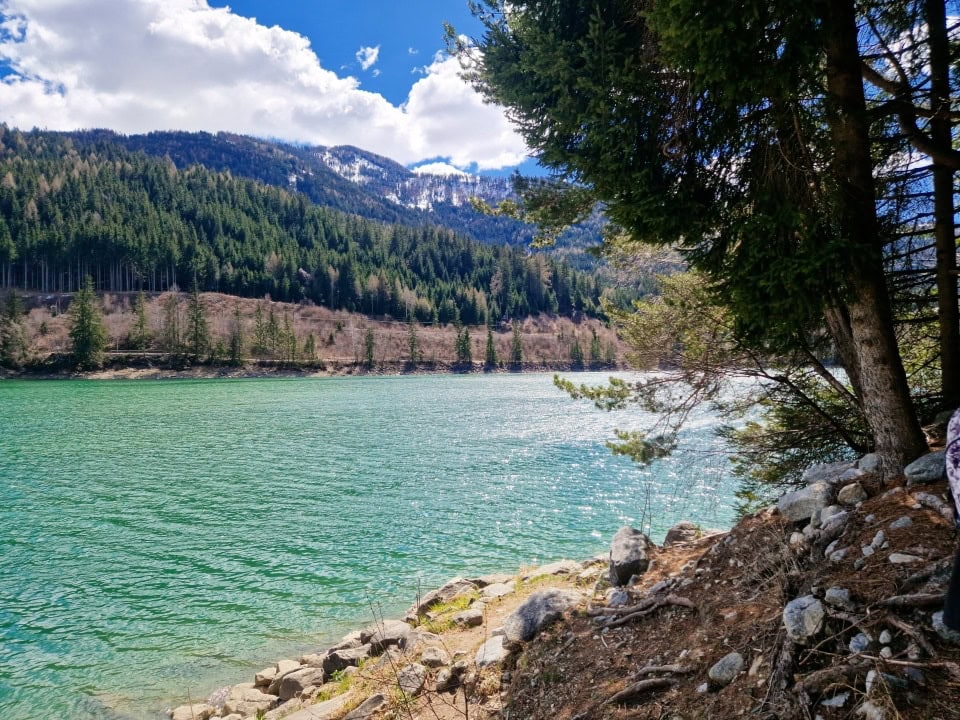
923, 0, 960, 409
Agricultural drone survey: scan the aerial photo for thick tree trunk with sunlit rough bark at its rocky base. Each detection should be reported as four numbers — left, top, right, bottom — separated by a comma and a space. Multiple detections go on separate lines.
819, 0, 927, 478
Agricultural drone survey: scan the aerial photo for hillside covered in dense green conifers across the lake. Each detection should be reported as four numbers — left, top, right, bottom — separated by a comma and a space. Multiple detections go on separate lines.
0, 126, 601, 324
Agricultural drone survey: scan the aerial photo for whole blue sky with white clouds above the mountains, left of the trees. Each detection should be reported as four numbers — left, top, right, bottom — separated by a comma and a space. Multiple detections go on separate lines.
0, 0, 535, 174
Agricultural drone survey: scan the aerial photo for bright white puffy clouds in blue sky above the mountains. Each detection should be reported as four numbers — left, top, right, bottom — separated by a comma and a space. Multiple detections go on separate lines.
0, 0, 526, 169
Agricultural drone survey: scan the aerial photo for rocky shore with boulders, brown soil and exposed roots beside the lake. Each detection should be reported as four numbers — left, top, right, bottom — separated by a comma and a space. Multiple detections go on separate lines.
170, 444, 960, 720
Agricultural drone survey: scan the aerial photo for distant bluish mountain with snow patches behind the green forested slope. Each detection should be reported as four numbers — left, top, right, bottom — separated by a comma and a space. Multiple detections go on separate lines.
68, 130, 602, 269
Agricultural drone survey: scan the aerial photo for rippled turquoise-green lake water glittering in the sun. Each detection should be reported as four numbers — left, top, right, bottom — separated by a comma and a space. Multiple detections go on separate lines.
0, 373, 733, 720
